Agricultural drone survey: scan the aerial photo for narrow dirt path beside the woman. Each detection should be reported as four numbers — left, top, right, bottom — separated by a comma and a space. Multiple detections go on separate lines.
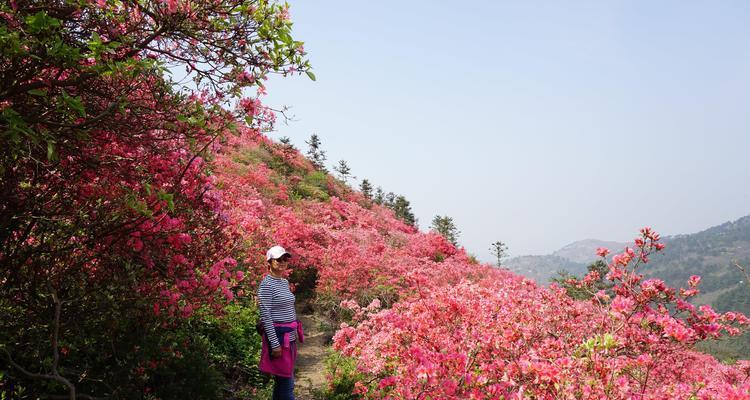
295, 313, 326, 400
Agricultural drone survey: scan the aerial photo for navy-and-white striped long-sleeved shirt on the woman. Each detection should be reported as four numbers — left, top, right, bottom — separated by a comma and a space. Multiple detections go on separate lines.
258, 274, 297, 349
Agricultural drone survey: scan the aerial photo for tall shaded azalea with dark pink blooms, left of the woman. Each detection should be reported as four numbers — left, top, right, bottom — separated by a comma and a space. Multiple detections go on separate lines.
0, 0, 312, 398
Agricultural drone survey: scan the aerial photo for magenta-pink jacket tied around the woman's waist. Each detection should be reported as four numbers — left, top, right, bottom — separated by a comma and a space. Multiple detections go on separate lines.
258, 321, 305, 378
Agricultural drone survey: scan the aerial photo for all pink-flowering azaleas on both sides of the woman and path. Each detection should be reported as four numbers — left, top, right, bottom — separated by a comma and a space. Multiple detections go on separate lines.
0, 0, 750, 400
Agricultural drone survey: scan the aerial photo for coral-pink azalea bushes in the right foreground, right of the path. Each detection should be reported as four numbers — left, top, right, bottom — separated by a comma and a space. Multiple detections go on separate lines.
335, 229, 750, 399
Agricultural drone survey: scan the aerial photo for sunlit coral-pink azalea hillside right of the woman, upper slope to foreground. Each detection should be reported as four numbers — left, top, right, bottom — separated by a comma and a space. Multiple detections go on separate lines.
216, 126, 750, 399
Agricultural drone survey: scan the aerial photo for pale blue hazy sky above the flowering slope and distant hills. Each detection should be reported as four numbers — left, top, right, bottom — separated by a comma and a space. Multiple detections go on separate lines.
266, 0, 750, 260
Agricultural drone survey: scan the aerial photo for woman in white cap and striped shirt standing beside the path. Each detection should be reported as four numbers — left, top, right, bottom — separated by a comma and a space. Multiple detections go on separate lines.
258, 246, 304, 400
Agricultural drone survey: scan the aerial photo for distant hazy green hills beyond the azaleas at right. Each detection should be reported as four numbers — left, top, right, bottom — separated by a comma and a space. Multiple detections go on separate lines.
505, 216, 750, 359
